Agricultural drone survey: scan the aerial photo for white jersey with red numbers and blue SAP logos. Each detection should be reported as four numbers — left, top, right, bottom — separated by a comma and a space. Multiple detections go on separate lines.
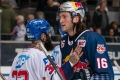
8, 46, 61, 80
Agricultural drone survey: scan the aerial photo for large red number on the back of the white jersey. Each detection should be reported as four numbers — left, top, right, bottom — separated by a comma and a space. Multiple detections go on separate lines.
12, 70, 28, 80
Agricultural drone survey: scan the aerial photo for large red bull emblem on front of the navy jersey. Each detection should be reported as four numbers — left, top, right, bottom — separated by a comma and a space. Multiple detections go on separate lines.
73, 59, 90, 72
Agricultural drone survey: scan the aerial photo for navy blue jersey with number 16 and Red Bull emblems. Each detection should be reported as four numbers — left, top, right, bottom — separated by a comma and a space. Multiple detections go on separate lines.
60, 30, 114, 80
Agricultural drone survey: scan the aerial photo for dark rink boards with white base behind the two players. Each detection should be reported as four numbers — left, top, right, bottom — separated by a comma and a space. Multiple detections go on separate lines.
0, 41, 120, 80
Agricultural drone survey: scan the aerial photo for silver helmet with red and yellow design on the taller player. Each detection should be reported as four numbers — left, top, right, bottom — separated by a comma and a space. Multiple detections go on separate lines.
56, 1, 85, 22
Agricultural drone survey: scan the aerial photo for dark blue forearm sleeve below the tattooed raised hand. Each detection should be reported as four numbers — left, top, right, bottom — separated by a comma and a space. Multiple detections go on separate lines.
62, 61, 74, 80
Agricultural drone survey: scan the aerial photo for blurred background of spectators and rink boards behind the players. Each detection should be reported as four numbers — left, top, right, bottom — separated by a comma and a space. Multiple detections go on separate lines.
0, 0, 120, 80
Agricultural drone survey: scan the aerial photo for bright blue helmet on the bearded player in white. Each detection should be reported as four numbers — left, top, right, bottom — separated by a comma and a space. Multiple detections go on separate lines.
26, 19, 50, 40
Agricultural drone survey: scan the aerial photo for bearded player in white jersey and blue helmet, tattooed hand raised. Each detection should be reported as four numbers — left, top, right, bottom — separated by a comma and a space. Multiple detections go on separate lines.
8, 19, 83, 80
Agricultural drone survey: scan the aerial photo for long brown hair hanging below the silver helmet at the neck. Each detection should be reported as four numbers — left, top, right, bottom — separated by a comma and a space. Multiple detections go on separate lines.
76, 14, 86, 34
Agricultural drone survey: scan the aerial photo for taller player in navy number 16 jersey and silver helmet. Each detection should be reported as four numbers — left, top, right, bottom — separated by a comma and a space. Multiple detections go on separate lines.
57, 1, 114, 80
